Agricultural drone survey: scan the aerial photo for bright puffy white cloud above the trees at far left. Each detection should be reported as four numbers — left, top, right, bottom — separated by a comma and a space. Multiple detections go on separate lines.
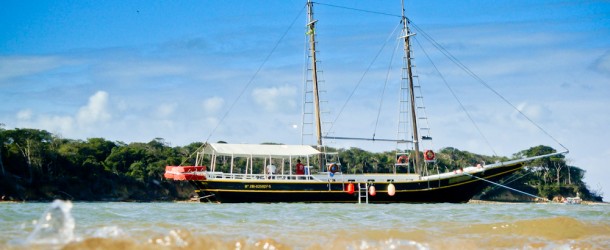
76, 91, 111, 125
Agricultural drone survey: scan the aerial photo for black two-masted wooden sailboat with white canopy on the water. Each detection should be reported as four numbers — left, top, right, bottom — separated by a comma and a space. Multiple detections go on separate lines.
165, 1, 566, 203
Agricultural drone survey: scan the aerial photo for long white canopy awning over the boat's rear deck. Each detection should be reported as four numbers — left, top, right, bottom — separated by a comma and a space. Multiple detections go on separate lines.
204, 143, 320, 158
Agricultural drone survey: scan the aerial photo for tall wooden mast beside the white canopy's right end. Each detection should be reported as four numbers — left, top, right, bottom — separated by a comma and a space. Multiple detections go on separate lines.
307, 0, 322, 149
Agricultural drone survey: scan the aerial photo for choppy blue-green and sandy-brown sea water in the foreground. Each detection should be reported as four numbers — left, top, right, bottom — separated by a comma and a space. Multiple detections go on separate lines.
0, 201, 610, 249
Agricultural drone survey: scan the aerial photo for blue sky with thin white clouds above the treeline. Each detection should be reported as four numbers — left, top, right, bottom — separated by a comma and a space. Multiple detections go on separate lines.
0, 0, 610, 200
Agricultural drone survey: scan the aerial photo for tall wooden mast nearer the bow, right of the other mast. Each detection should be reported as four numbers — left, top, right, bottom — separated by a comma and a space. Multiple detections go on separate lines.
402, 0, 421, 173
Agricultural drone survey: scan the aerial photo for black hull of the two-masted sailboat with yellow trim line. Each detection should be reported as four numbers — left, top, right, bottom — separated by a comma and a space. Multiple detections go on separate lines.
190, 163, 523, 203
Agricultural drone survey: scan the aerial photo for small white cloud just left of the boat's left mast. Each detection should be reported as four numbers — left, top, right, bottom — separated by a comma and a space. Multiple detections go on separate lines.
252, 86, 297, 112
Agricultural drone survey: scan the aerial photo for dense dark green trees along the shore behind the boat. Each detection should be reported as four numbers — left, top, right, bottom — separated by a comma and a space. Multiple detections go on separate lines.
0, 127, 603, 203
